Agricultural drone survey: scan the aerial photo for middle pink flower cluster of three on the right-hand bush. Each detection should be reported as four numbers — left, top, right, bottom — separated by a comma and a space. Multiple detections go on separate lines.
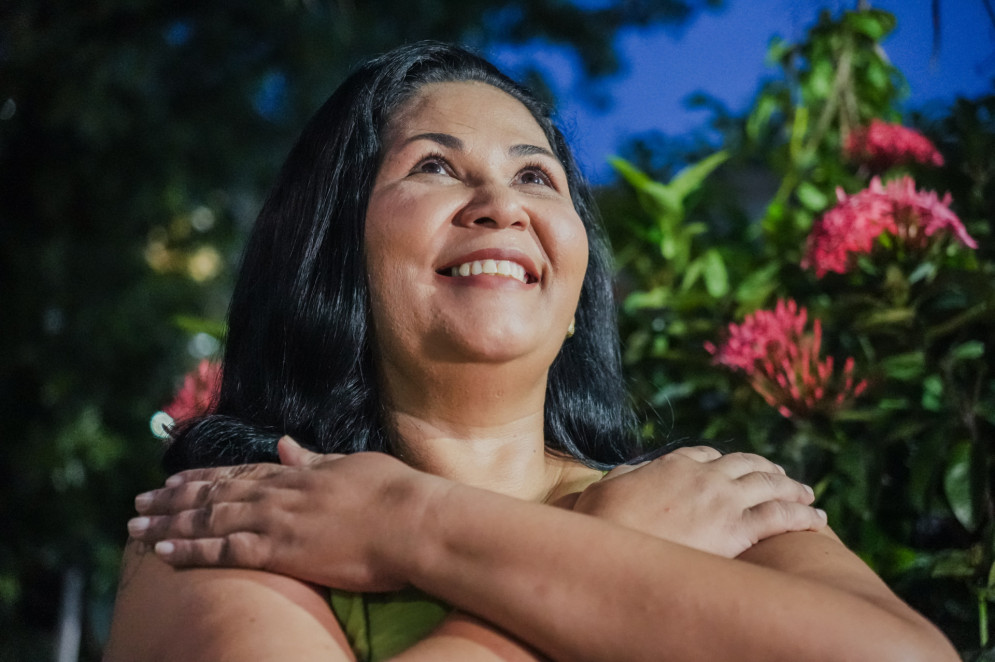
801, 176, 978, 278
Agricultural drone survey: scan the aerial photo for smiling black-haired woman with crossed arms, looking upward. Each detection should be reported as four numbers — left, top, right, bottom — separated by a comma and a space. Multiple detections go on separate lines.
107, 44, 956, 660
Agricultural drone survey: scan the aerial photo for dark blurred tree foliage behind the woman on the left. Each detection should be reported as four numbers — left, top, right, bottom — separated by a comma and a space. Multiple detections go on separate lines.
0, 0, 720, 660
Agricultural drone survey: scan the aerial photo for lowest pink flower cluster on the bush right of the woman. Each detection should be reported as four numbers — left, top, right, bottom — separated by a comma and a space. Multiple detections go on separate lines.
705, 299, 867, 418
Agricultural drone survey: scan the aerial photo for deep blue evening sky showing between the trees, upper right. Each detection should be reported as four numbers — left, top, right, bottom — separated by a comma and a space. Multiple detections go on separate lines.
492, 0, 995, 182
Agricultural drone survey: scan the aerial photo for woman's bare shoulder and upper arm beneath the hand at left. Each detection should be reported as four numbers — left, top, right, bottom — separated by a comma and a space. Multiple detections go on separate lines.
104, 541, 353, 662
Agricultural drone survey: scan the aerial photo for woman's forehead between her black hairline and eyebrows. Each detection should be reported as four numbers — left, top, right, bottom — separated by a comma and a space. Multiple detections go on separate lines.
387, 81, 551, 150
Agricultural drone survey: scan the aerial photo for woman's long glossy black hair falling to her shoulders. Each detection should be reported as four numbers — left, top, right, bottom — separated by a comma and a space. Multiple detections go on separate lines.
163, 42, 635, 472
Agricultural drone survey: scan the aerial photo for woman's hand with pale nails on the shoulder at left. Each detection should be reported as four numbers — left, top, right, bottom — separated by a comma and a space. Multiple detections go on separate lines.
128, 437, 445, 591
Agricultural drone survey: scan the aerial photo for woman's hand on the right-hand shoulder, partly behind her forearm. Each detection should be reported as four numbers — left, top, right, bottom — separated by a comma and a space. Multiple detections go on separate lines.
573, 446, 826, 558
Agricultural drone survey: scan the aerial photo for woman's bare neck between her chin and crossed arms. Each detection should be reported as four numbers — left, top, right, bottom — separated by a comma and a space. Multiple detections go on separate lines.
381, 363, 569, 501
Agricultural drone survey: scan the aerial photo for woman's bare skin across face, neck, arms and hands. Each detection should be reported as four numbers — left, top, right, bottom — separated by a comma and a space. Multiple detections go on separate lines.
108, 83, 957, 661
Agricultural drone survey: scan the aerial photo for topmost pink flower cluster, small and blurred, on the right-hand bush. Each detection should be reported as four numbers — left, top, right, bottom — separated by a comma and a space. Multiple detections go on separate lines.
843, 119, 943, 172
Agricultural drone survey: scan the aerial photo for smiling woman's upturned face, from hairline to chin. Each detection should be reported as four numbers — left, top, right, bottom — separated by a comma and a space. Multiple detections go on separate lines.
366, 82, 587, 369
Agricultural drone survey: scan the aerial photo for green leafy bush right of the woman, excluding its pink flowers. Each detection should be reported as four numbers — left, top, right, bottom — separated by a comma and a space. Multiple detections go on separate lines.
602, 5, 995, 659
